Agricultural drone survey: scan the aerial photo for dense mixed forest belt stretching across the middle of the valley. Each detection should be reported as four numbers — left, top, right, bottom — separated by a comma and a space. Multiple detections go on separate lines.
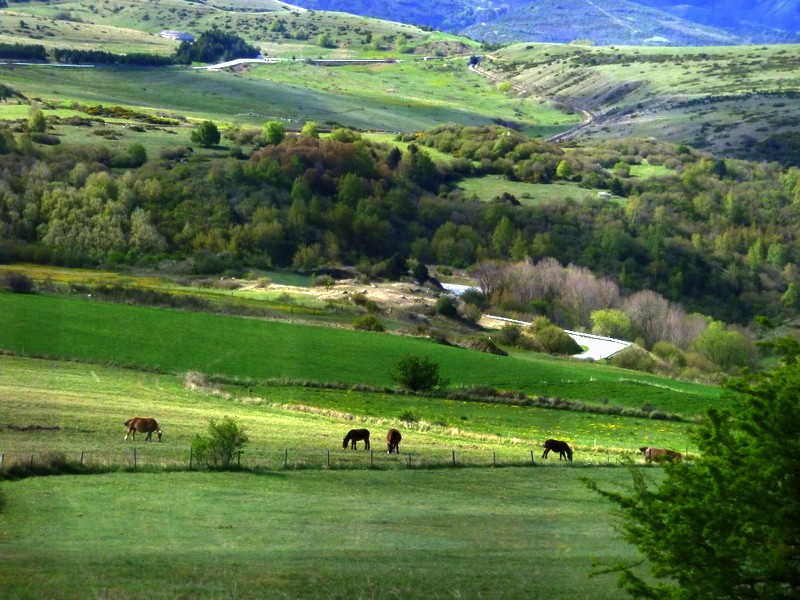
0, 126, 800, 343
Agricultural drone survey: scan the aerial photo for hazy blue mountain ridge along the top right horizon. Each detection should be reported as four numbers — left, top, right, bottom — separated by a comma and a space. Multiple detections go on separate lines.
286, 0, 800, 46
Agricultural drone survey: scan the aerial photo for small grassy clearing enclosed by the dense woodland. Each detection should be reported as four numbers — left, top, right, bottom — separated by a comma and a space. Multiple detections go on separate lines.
458, 175, 597, 206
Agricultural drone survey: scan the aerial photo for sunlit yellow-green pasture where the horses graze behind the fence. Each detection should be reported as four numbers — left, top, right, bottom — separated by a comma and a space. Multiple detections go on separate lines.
0, 356, 694, 468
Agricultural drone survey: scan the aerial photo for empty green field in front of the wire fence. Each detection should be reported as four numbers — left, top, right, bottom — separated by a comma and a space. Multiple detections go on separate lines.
0, 468, 658, 600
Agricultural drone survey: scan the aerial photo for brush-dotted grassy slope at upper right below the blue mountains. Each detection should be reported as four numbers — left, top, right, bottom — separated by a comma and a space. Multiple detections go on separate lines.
482, 44, 800, 164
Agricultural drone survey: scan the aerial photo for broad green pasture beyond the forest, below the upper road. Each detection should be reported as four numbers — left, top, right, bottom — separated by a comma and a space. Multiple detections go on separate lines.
3, 61, 571, 134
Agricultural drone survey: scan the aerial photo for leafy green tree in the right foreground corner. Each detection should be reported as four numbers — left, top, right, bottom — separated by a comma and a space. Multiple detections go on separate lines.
589, 340, 800, 600
